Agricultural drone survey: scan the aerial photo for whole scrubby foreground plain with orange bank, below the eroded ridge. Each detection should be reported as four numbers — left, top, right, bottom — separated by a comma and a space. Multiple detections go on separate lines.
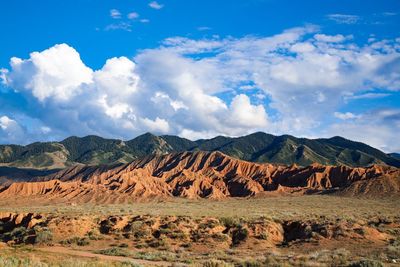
0, 195, 400, 266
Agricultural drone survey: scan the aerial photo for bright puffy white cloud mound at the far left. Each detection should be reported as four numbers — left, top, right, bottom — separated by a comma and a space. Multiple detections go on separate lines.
5, 44, 92, 102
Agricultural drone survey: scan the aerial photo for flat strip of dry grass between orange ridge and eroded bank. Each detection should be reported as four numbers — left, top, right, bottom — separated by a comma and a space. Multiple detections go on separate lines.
0, 195, 400, 220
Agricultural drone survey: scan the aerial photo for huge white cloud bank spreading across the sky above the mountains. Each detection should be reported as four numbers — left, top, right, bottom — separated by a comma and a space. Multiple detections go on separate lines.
2, 26, 400, 152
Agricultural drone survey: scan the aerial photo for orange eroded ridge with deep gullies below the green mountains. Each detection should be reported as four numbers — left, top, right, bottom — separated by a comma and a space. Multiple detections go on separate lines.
0, 152, 400, 202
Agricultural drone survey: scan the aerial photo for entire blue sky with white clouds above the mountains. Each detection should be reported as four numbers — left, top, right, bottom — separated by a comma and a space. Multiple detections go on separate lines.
0, 0, 400, 152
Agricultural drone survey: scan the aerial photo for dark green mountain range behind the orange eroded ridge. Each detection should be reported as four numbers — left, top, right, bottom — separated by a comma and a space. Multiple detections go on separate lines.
0, 132, 400, 169
